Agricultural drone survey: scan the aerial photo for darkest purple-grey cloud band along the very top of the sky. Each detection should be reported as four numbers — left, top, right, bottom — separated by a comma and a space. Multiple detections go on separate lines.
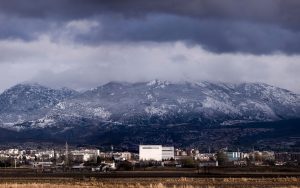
0, 0, 300, 27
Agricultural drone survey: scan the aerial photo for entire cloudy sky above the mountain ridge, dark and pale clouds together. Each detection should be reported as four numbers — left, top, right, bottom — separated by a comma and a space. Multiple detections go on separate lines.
0, 0, 300, 93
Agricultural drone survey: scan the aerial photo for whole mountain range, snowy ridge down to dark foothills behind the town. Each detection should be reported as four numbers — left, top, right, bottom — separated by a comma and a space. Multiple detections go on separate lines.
0, 80, 300, 151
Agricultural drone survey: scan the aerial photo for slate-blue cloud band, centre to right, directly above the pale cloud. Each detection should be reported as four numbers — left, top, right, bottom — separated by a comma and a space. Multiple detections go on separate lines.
75, 14, 300, 54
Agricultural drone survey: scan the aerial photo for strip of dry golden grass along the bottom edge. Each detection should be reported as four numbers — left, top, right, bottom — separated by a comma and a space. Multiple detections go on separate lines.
0, 178, 300, 188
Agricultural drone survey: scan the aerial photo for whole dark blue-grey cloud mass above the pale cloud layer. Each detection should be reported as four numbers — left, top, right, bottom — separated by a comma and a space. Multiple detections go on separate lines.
0, 0, 300, 54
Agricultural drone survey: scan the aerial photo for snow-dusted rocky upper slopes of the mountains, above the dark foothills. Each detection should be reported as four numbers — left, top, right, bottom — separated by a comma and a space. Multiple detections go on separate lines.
0, 80, 300, 130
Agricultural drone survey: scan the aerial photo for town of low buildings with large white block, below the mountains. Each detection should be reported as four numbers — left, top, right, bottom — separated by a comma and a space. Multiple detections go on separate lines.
0, 144, 300, 172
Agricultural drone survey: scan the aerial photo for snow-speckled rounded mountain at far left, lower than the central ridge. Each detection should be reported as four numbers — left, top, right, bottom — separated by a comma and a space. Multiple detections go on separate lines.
0, 84, 77, 123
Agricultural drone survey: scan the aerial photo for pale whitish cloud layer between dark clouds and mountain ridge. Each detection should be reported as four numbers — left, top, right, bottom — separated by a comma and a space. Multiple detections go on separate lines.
0, 36, 300, 93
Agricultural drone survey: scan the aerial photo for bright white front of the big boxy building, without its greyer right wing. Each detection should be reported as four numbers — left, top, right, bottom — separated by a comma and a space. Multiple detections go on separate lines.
139, 145, 162, 161
